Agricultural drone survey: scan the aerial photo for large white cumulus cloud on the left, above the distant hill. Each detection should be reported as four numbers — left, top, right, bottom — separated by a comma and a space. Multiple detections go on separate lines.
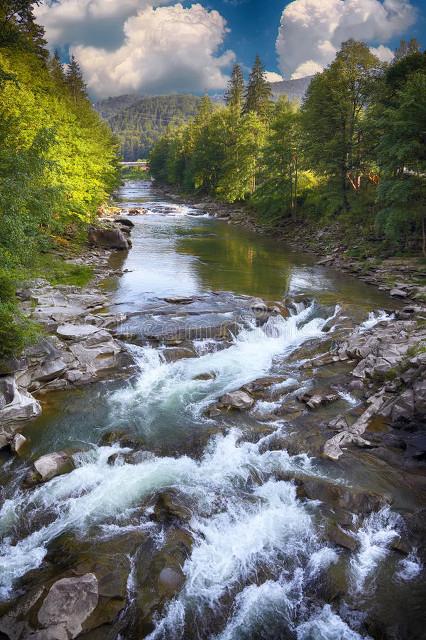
38, 0, 235, 97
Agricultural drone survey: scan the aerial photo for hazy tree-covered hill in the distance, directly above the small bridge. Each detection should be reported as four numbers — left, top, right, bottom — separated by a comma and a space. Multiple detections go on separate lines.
95, 95, 200, 161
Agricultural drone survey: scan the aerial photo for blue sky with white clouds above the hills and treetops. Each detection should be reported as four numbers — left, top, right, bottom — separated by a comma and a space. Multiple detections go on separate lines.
36, 0, 426, 98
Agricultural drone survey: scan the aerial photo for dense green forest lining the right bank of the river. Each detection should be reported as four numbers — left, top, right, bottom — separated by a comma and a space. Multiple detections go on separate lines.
151, 39, 426, 255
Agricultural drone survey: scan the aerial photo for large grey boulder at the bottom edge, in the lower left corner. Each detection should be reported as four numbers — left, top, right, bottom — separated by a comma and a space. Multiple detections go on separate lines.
35, 573, 99, 640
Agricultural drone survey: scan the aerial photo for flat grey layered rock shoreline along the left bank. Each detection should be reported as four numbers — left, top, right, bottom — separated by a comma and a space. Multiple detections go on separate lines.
0, 215, 133, 449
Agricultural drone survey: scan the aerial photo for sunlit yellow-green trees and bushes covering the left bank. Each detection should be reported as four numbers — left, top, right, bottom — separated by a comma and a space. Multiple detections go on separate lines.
0, 0, 119, 358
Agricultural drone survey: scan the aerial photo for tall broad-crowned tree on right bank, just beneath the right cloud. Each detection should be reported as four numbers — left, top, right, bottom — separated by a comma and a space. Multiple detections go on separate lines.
302, 40, 381, 211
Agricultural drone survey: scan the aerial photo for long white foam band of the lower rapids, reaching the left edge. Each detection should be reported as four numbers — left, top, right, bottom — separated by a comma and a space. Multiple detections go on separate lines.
0, 430, 310, 597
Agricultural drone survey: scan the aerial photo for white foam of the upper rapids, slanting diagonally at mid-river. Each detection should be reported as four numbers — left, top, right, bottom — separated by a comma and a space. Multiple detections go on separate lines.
111, 306, 332, 424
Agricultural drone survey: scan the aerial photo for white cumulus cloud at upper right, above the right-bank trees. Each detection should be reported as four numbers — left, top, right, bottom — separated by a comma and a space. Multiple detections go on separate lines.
276, 0, 416, 78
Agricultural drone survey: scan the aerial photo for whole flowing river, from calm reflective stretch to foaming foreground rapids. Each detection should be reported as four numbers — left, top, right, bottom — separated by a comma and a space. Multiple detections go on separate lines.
0, 182, 422, 640
